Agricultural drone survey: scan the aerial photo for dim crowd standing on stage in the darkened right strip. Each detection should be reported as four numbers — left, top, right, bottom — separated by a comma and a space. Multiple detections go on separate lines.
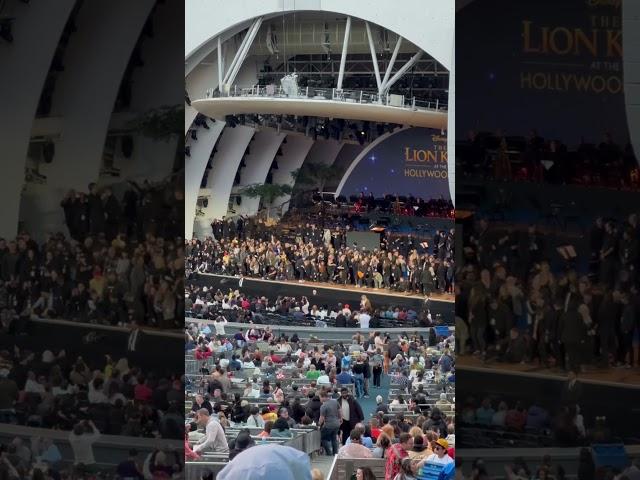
456, 214, 640, 371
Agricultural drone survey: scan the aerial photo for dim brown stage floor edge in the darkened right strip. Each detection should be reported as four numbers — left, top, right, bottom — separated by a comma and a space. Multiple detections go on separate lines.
456, 355, 640, 389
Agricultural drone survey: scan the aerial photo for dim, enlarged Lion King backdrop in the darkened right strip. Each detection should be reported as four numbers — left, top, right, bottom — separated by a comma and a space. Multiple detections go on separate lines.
456, 0, 628, 147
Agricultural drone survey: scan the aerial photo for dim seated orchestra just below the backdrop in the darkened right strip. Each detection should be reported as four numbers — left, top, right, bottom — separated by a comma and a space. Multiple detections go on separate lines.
456, 129, 640, 189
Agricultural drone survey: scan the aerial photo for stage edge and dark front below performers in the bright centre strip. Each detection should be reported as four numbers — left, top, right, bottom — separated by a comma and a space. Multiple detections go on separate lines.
189, 273, 455, 325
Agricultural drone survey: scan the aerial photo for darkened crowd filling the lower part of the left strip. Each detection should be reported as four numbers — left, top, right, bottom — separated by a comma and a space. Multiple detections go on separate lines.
0, 177, 184, 480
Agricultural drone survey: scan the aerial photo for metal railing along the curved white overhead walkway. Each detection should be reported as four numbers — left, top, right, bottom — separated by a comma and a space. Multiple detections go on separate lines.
205, 85, 447, 112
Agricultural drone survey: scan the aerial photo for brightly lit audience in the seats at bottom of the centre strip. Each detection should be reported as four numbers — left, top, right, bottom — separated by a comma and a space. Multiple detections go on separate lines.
185, 316, 455, 480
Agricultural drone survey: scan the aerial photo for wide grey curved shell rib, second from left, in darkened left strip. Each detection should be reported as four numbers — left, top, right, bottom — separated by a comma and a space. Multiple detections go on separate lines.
20, 0, 154, 238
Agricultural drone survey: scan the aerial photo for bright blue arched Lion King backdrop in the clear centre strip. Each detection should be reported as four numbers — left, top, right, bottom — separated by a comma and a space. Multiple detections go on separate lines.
338, 128, 451, 200
